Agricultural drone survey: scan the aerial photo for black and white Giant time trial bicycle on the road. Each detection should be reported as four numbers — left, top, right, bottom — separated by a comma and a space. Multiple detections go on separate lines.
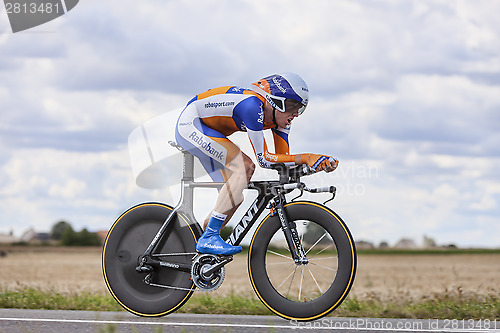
102, 142, 357, 321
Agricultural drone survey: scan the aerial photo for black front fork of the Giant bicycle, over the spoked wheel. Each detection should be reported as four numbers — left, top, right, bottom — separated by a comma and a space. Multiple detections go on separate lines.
269, 193, 309, 265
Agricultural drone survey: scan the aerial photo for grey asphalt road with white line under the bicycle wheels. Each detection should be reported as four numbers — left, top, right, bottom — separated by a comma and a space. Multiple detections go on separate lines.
0, 309, 500, 333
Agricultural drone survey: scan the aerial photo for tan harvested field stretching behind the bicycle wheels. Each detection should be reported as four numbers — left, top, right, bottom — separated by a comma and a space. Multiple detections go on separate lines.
0, 247, 500, 317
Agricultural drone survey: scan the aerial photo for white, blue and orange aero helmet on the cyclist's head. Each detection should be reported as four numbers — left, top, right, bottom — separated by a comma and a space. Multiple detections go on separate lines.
251, 73, 309, 115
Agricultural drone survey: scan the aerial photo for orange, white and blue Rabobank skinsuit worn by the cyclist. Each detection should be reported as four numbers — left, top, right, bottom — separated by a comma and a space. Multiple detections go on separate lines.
176, 86, 291, 181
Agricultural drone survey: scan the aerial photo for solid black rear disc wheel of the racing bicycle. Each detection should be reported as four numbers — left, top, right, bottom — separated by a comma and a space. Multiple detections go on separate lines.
102, 202, 200, 317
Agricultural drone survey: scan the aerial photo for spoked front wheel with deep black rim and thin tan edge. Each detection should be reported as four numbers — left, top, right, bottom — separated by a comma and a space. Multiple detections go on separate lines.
248, 201, 357, 321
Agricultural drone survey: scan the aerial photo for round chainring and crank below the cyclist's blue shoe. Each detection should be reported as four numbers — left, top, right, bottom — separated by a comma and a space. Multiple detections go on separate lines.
191, 254, 226, 291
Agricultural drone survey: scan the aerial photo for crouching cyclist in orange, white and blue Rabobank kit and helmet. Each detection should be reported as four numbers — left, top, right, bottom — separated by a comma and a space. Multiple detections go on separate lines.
175, 73, 338, 255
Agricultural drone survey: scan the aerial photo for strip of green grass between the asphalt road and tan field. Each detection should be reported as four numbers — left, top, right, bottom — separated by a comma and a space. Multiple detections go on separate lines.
0, 288, 500, 320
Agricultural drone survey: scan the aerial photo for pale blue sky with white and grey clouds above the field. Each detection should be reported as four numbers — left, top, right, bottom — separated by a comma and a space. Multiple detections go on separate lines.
0, 0, 500, 247
